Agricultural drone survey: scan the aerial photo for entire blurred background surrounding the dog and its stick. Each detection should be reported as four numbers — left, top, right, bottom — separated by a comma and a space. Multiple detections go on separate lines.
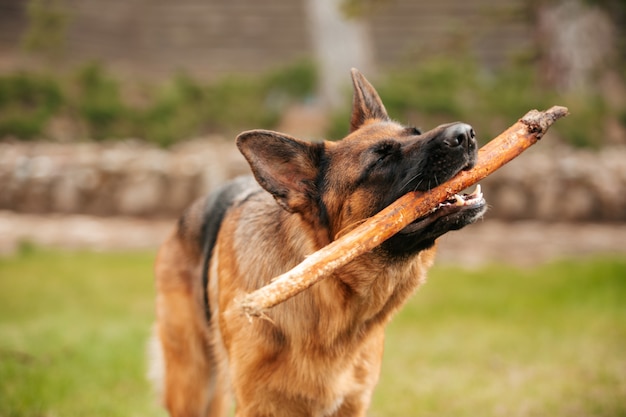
0, 0, 626, 417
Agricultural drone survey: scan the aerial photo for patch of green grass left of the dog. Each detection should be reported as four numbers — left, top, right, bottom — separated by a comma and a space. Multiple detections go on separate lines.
0, 250, 164, 417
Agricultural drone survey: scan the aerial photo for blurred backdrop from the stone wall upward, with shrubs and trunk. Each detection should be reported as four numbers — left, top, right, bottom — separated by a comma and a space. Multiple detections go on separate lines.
0, 0, 626, 231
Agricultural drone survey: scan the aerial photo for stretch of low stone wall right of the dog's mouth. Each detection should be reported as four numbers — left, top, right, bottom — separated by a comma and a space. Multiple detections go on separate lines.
482, 144, 626, 221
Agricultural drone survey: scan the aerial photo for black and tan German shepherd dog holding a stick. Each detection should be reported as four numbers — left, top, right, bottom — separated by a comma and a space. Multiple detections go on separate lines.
153, 70, 486, 417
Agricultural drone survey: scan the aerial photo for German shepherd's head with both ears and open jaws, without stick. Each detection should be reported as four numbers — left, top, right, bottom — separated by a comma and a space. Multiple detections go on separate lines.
237, 70, 486, 256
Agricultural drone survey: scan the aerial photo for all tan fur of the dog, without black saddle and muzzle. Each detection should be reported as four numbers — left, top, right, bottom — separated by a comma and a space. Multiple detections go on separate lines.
156, 70, 478, 417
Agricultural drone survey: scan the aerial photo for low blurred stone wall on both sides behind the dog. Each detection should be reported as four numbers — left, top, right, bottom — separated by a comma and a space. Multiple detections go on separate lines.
0, 139, 626, 221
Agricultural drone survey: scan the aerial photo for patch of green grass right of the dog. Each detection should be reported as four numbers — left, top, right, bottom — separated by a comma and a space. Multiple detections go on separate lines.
372, 259, 626, 417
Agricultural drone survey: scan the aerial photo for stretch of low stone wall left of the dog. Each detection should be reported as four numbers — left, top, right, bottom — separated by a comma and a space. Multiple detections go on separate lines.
0, 141, 248, 216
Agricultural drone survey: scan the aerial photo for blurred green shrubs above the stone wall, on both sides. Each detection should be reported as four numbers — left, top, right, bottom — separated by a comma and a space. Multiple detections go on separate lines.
0, 56, 626, 147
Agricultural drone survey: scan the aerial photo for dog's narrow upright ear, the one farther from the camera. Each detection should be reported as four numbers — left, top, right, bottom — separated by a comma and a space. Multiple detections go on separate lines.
350, 68, 389, 132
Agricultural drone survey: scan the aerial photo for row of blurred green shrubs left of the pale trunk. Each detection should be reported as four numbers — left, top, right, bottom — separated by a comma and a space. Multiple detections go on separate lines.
0, 61, 316, 146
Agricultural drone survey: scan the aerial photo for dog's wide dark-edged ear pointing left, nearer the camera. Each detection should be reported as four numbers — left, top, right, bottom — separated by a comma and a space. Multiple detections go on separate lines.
237, 130, 323, 212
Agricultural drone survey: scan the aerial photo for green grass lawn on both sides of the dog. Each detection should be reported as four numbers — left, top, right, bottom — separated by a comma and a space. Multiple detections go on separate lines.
0, 247, 626, 417
